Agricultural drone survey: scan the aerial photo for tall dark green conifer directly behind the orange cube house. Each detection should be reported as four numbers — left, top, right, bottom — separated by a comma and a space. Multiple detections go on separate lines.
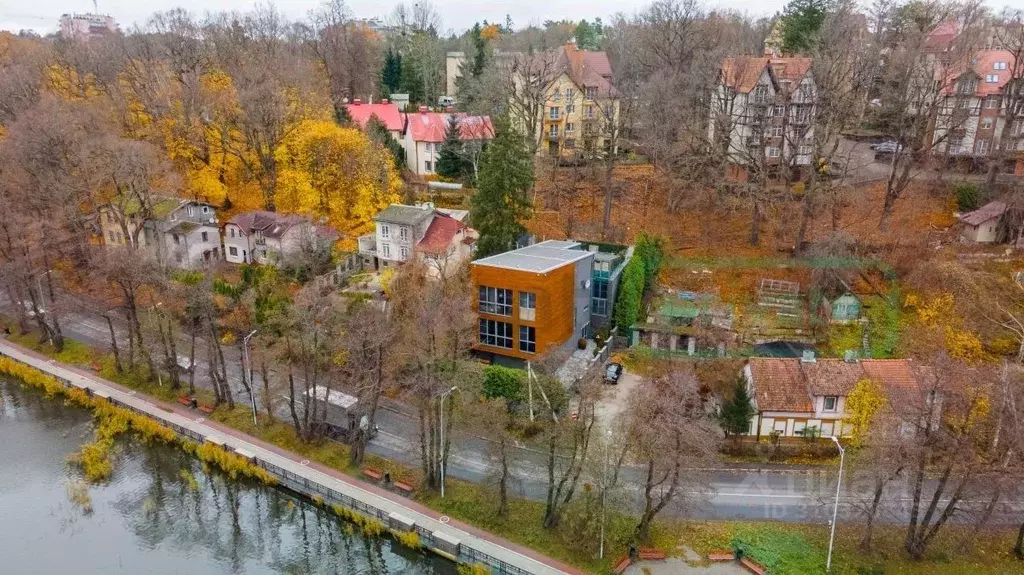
471, 116, 534, 258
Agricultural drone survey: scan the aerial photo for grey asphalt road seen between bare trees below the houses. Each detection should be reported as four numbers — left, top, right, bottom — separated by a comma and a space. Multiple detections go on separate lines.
0, 295, 1024, 525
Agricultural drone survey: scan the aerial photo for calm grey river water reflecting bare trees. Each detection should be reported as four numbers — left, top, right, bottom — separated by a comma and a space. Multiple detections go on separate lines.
0, 379, 456, 575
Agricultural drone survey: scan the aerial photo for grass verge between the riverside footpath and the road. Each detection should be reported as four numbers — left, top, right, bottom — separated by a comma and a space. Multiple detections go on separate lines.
12, 327, 1024, 575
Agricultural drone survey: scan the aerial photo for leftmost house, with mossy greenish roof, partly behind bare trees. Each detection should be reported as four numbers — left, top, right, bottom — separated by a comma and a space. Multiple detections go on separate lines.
98, 194, 223, 268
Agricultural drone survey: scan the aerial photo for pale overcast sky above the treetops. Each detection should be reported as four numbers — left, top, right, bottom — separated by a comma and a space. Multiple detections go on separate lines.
0, 0, 794, 34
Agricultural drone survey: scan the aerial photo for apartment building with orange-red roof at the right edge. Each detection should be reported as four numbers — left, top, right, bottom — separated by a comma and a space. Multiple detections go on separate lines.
933, 50, 1024, 159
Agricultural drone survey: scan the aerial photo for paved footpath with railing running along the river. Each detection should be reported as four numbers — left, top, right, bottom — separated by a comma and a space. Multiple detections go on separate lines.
0, 339, 583, 575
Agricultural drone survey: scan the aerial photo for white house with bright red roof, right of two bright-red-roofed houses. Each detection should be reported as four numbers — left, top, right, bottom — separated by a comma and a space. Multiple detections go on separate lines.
398, 106, 495, 176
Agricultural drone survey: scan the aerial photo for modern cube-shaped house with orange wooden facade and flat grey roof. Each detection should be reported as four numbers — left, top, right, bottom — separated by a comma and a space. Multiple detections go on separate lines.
471, 239, 597, 365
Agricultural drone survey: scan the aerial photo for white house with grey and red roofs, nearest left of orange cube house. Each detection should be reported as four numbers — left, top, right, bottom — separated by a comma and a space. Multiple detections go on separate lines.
358, 203, 478, 276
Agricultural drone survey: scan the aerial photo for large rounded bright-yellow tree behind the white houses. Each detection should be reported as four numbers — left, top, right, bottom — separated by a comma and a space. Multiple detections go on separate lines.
275, 121, 401, 234
